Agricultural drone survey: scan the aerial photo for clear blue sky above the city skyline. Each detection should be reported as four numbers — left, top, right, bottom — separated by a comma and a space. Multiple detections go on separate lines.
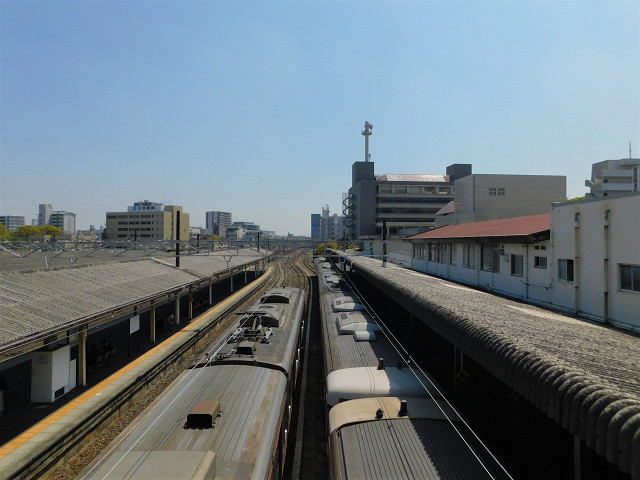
0, 0, 640, 235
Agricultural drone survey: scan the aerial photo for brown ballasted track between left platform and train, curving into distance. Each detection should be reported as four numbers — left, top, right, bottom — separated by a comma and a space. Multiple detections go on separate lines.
41, 250, 313, 480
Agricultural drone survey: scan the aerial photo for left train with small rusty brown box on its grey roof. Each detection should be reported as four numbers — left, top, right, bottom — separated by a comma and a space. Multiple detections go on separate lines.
78, 287, 305, 480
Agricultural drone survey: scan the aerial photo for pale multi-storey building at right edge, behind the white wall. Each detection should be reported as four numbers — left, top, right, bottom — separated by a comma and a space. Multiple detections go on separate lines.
584, 157, 640, 198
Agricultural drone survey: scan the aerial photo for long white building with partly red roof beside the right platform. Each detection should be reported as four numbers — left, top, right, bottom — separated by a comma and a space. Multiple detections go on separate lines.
407, 193, 640, 331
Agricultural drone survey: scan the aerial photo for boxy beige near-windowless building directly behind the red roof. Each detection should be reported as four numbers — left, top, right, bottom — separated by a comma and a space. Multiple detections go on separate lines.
436, 171, 567, 227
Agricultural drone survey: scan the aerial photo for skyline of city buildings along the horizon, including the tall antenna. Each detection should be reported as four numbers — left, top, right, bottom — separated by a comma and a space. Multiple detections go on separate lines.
0, 150, 640, 244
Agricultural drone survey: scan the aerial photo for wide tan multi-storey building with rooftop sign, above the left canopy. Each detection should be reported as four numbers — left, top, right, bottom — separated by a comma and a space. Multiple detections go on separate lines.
103, 200, 189, 240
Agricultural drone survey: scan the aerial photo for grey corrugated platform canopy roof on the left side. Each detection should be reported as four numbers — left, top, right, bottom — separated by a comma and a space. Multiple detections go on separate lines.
0, 249, 263, 361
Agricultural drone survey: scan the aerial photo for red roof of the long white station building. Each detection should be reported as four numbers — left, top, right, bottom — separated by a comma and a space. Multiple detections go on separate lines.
408, 213, 551, 240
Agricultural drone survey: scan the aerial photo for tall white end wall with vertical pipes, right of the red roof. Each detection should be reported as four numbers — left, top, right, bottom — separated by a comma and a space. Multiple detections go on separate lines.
551, 193, 640, 329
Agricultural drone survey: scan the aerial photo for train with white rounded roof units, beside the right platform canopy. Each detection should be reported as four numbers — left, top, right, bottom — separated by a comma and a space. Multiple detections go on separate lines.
315, 257, 511, 480
